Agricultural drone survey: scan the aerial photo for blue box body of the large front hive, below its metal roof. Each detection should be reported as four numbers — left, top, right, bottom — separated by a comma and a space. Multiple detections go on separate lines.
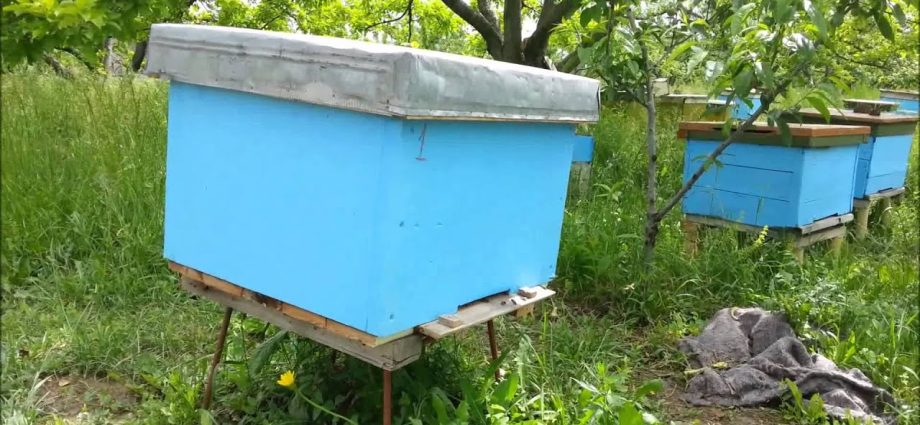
164, 82, 576, 336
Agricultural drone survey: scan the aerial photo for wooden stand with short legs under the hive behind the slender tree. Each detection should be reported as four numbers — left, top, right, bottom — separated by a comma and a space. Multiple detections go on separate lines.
681, 214, 853, 263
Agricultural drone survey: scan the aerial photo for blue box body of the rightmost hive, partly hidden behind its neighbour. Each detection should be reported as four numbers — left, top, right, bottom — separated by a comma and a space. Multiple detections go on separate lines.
853, 134, 913, 199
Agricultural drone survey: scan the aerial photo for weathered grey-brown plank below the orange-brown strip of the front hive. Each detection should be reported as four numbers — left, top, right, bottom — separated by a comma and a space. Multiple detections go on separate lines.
179, 276, 424, 370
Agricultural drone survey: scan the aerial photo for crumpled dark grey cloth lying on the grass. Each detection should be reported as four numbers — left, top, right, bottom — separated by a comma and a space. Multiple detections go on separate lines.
678, 308, 894, 424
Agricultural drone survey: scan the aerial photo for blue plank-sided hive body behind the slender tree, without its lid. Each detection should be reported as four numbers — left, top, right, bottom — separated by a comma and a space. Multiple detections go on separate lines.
682, 139, 858, 227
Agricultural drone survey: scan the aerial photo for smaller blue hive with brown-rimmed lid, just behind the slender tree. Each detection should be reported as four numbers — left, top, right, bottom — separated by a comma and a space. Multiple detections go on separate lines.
679, 122, 869, 228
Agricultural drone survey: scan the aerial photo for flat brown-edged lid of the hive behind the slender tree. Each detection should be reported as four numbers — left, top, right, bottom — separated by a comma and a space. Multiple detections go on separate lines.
678, 121, 870, 148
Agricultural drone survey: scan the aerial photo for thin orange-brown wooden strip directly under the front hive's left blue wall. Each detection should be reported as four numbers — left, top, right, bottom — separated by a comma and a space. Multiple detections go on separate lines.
169, 261, 412, 347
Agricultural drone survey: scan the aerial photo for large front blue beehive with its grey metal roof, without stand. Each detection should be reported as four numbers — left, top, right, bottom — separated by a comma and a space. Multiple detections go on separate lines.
147, 25, 598, 336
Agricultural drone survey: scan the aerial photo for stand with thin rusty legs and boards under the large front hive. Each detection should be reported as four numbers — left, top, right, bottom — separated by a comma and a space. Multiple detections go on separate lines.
169, 262, 555, 425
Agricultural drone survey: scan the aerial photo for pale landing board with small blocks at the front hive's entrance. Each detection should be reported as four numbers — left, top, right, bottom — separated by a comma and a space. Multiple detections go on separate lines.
418, 286, 556, 340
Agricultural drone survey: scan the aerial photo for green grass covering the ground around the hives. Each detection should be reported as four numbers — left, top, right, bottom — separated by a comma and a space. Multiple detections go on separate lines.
0, 72, 920, 424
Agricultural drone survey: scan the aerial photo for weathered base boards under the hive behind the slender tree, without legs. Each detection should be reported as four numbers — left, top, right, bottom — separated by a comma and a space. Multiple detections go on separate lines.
684, 214, 853, 248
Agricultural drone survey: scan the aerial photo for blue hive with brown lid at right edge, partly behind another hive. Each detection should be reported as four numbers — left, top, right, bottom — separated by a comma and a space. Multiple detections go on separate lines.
800, 109, 918, 199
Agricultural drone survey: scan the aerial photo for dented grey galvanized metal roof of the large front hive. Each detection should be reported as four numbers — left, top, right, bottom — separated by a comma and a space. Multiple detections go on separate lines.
147, 24, 599, 123
